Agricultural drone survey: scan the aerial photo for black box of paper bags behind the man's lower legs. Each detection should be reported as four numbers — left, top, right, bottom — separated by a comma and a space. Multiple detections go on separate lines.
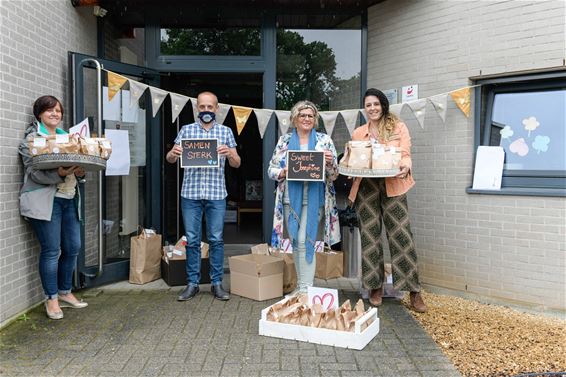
161, 240, 210, 287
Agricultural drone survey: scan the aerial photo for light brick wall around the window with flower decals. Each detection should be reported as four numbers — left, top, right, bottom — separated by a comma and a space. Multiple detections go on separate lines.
368, 0, 566, 310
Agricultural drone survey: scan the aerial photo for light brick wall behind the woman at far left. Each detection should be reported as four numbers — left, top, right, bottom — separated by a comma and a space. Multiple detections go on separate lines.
0, 0, 96, 325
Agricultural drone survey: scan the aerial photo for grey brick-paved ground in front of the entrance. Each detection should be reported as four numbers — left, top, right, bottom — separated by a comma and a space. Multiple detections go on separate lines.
0, 277, 460, 377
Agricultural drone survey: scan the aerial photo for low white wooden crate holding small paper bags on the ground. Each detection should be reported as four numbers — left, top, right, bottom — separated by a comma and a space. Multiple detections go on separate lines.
259, 299, 379, 350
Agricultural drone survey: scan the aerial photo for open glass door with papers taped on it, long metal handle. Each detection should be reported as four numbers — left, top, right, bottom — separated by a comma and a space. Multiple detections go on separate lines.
69, 53, 161, 287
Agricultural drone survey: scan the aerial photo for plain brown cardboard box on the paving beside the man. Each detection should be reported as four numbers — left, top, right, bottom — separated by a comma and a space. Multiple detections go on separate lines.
229, 254, 285, 301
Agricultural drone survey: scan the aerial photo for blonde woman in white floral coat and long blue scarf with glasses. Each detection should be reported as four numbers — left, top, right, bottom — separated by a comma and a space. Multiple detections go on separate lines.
268, 101, 340, 294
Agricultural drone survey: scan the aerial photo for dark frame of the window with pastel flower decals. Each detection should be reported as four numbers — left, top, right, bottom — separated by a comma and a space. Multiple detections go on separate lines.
466, 67, 566, 197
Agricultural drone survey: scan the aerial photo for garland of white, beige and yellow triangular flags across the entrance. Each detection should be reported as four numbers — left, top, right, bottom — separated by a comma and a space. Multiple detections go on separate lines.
105, 70, 478, 138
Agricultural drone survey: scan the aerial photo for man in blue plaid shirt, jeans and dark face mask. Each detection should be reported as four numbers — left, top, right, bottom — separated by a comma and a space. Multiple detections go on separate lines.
166, 92, 241, 301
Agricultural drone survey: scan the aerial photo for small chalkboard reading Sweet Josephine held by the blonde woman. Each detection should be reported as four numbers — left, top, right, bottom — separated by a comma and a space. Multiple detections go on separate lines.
287, 151, 325, 181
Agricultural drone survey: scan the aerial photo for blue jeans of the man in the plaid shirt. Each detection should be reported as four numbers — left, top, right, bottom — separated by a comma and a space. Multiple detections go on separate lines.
181, 197, 226, 285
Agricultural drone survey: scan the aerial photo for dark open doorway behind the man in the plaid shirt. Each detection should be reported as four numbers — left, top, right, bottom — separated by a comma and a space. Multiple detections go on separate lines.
161, 72, 264, 247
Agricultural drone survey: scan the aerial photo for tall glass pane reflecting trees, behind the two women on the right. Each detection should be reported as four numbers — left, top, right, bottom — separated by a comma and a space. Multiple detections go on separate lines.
276, 15, 362, 153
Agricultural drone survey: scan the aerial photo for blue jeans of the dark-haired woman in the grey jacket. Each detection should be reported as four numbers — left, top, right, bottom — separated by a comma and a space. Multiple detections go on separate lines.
29, 197, 81, 299
